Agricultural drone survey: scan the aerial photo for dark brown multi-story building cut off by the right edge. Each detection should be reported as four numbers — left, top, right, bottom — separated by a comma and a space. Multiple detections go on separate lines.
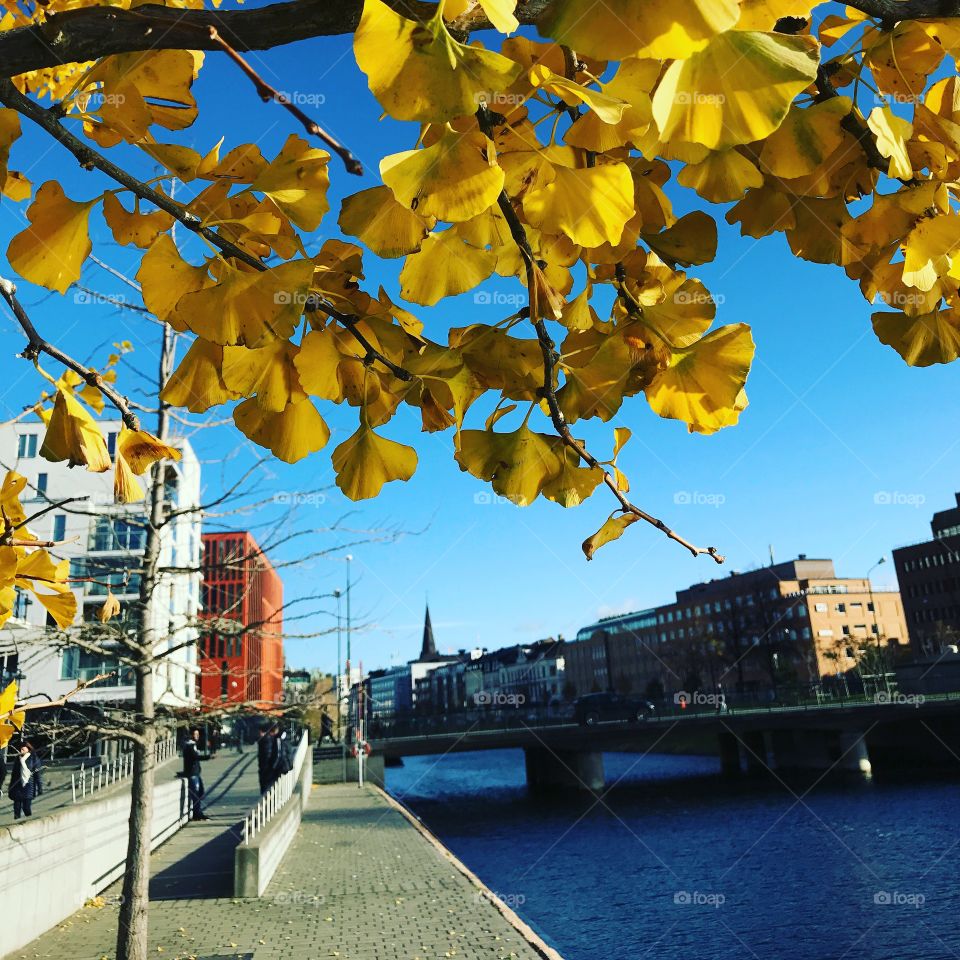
893, 493, 960, 656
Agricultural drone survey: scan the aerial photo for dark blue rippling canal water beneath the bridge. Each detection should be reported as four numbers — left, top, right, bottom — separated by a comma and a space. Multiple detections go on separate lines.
387, 750, 960, 960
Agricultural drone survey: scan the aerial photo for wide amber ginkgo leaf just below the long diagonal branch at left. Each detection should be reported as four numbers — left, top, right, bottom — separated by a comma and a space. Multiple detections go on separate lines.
171, 260, 314, 348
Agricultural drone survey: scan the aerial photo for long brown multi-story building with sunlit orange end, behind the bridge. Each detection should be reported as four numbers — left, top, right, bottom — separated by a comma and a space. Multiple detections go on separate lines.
565, 554, 907, 698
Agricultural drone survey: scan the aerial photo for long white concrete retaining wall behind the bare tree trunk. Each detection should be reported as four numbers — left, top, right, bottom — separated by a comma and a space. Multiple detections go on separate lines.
0, 769, 187, 957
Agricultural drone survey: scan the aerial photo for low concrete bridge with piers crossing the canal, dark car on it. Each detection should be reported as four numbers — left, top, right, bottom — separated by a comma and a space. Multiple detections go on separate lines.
368, 694, 960, 790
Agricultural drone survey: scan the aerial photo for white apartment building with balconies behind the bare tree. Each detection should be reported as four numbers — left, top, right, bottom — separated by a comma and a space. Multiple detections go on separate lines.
0, 420, 201, 707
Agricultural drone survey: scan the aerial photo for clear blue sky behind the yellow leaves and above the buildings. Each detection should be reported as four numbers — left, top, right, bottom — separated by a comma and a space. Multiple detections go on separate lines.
0, 11, 960, 669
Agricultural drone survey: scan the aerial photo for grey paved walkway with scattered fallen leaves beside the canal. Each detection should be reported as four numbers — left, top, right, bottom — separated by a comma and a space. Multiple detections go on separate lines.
10, 773, 556, 960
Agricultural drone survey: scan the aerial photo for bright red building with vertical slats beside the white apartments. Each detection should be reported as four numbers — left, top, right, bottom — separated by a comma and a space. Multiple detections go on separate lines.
200, 531, 283, 706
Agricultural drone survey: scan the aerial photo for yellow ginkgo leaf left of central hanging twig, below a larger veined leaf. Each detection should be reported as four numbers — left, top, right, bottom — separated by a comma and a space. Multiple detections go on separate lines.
400, 230, 497, 306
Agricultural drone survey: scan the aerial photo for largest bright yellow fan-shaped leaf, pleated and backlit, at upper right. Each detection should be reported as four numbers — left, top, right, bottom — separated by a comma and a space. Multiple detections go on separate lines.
653, 30, 818, 150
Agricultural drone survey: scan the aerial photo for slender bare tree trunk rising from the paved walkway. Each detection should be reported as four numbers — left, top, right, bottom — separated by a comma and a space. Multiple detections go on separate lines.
117, 327, 175, 960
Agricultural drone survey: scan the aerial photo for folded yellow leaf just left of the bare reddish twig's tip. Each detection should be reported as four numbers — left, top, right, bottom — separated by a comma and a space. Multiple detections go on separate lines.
250, 134, 330, 230
